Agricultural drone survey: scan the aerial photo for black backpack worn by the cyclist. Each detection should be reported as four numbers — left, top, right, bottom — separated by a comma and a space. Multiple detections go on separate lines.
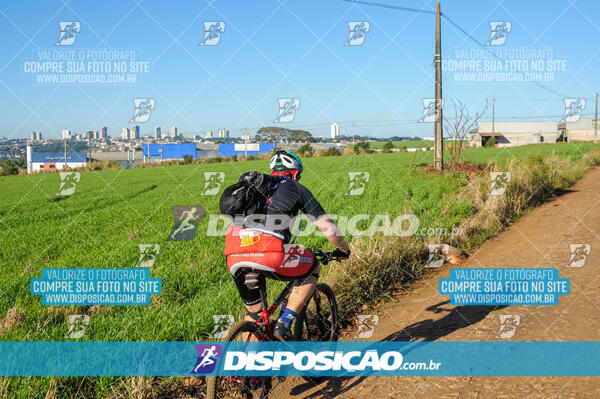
219, 171, 283, 217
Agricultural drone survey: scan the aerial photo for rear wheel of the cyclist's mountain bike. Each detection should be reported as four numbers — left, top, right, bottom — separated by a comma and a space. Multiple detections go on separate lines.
206, 321, 272, 399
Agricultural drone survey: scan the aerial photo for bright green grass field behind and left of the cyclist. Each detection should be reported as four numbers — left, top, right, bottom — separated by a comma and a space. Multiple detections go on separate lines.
0, 144, 600, 397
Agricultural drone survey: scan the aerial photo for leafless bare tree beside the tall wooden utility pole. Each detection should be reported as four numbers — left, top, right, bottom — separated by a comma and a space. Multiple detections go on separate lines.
443, 99, 488, 171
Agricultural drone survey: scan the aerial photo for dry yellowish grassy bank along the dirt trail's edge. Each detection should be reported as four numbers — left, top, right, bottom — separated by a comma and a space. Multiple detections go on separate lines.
326, 151, 600, 317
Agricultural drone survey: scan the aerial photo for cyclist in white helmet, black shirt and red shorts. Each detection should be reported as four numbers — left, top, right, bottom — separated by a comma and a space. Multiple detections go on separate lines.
225, 150, 350, 341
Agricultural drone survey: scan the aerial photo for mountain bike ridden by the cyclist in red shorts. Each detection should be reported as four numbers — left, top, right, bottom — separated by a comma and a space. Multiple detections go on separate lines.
206, 251, 341, 399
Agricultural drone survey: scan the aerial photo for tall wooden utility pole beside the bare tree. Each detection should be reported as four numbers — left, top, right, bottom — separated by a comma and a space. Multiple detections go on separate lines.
433, 1, 444, 171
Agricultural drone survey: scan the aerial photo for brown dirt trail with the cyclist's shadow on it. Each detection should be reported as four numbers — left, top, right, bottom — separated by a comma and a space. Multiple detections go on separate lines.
273, 168, 600, 399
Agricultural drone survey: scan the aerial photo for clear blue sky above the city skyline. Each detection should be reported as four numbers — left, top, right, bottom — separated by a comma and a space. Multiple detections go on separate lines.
0, 0, 600, 137
